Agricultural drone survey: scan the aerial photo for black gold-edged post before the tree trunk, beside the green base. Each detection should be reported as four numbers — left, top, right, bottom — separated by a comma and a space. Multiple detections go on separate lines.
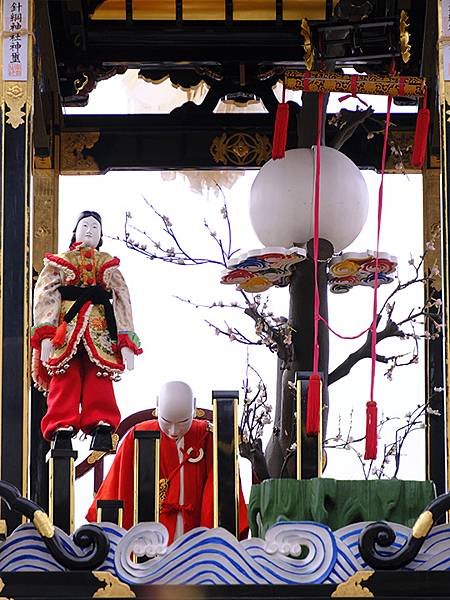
295, 372, 322, 479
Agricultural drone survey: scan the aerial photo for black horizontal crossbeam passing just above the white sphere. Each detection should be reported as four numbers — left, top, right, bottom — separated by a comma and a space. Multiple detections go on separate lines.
62, 110, 415, 173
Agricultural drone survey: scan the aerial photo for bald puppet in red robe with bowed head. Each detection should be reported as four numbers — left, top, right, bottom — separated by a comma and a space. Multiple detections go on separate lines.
86, 381, 248, 542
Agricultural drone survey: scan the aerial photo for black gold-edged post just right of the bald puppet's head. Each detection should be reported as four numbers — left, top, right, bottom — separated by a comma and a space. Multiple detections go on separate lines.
212, 391, 239, 537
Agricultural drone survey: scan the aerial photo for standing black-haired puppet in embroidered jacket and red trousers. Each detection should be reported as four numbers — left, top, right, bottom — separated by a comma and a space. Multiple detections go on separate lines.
31, 211, 142, 450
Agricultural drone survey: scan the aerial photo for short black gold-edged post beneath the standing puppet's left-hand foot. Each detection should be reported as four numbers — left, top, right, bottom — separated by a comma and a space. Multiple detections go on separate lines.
48, 448, 78, 533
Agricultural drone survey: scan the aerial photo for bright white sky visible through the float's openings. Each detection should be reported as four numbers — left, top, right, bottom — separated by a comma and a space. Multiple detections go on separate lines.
59, 75, 424, 522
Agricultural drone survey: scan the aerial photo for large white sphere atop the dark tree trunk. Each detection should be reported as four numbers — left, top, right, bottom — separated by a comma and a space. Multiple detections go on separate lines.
250, 146, 369, 252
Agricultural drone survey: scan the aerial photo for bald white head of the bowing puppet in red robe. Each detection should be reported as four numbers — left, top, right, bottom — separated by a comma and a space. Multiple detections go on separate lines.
158, 381, 195, 440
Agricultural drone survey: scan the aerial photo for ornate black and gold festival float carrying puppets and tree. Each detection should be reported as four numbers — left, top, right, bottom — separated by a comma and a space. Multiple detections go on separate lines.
0, 0, 450, 600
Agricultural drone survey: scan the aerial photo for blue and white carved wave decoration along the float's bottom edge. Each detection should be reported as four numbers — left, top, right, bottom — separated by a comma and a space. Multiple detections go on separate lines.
0, 521, 450, 585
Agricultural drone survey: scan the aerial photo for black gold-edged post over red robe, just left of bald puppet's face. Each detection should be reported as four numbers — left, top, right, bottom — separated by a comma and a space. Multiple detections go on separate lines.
134, 431, 160, 525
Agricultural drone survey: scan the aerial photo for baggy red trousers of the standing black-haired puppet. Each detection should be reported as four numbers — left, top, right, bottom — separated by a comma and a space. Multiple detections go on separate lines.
41, 351, 120, 440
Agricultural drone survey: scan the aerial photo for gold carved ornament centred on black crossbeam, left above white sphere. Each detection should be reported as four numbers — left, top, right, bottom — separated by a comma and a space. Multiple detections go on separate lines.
209, 133, 272, 167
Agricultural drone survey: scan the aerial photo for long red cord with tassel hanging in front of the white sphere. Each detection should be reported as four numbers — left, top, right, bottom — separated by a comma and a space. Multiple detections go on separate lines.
306, 92, 323, 435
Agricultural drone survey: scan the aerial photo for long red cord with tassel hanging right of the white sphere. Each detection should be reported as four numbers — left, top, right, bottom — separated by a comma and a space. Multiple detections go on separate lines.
364, 96, 392, 460
